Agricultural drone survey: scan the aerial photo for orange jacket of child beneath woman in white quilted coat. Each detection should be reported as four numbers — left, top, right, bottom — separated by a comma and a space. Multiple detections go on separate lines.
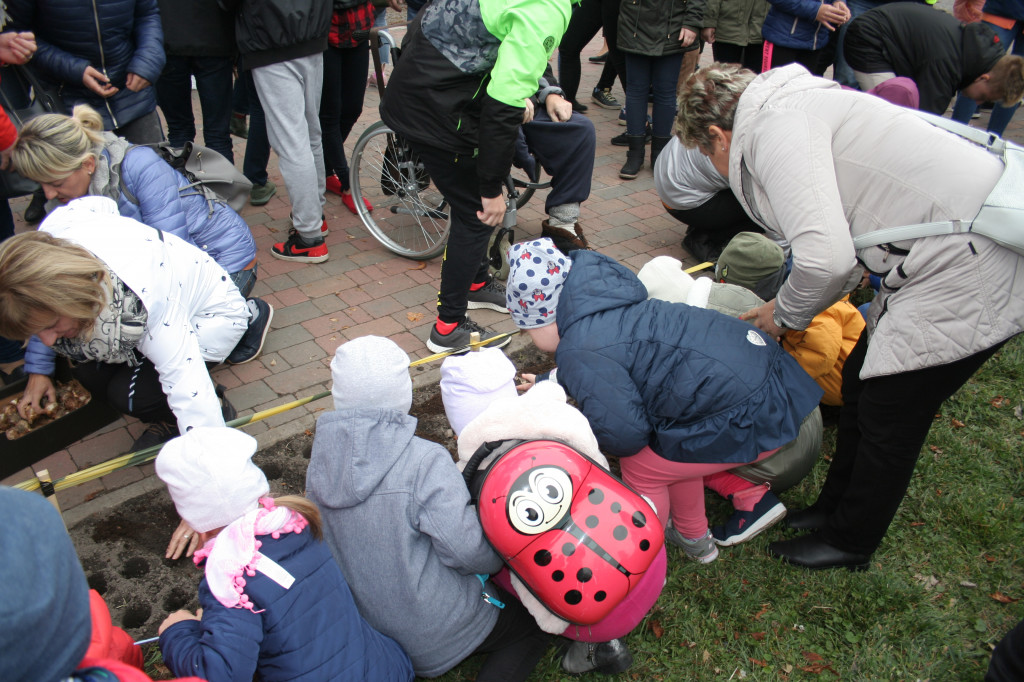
782, 296, 864, 406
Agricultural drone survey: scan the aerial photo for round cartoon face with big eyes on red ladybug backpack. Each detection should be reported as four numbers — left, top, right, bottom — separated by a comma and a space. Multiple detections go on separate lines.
508, 466, 572, 536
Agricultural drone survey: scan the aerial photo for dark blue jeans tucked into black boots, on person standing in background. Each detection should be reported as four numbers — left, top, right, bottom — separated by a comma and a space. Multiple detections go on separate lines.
626, 52, 683, 137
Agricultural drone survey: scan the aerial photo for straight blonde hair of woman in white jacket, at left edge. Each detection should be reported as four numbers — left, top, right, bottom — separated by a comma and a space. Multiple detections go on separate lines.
0, 231, 110, 340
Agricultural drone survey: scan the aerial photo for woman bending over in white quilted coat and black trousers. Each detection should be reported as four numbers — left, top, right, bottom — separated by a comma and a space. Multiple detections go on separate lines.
677, 63, 1024, 569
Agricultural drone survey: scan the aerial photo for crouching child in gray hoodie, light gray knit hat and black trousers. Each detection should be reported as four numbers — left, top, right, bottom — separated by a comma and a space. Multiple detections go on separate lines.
306, 336, 551, 682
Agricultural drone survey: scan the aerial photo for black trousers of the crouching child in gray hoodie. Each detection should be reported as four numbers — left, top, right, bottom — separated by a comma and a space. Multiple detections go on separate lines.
473, 583, 552, 682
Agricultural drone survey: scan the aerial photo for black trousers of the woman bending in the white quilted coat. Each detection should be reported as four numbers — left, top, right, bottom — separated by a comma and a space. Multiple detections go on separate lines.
815, 332, 1002, 554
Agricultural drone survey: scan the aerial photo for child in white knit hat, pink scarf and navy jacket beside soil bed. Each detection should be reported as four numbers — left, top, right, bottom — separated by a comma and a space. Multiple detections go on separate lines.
157, 427, 413, 682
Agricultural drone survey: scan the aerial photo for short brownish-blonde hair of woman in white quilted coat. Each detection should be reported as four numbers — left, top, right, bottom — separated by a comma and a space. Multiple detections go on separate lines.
672, 61, 756, 153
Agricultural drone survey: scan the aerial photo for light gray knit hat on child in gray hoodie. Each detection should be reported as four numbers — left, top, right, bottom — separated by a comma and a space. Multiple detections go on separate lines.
331, 336, 413, 413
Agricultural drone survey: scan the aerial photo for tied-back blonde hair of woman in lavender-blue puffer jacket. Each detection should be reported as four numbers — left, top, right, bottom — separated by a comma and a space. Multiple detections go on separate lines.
11, 104, 103, 182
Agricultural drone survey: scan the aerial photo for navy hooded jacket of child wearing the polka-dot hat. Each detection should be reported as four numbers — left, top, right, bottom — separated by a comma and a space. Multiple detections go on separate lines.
555, 251, 821, 462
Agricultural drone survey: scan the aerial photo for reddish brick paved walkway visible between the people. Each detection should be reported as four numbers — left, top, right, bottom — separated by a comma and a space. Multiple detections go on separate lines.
2, 33, 1024, 511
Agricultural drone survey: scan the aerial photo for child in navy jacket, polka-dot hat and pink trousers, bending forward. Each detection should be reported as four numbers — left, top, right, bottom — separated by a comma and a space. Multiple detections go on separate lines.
507, 239, 821, 563
